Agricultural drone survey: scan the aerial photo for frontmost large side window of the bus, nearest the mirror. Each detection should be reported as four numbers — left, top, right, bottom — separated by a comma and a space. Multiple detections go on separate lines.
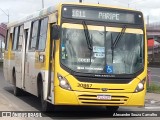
38, 18, 48, 51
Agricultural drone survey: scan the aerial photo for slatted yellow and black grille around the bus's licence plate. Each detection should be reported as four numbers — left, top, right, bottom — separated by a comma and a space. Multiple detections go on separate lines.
78, 94, 128, 105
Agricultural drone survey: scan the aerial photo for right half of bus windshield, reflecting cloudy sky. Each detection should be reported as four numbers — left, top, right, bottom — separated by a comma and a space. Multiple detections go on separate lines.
106, 32, 143, 74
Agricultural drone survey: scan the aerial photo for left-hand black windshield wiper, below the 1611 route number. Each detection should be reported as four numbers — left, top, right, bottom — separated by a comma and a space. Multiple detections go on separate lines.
82, 21, 93, 50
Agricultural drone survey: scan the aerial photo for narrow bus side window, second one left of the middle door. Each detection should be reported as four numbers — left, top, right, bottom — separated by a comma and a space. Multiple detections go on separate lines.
12, 27, 19, 50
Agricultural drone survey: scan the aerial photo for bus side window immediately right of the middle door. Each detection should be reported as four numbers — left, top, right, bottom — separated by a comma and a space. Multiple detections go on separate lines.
29, 20, 39, 51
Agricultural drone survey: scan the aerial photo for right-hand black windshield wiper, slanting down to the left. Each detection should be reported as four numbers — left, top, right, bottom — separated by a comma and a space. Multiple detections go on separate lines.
112, 26, 126, 50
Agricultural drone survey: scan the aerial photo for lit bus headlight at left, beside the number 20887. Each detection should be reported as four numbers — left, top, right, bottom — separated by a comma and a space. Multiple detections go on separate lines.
57, 74, 72, 90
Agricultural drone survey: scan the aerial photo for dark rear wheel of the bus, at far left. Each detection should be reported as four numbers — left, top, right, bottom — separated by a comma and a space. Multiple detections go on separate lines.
13, 72, 22, 96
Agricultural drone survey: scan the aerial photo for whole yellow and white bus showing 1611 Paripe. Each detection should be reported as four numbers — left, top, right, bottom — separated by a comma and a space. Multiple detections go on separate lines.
4, 3, 147, 111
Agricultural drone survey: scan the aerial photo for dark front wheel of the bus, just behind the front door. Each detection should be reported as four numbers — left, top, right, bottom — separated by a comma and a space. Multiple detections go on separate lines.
39, 82, 54, 112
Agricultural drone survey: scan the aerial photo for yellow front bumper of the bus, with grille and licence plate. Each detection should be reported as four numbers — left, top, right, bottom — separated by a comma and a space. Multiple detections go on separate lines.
53, 87, 145, 106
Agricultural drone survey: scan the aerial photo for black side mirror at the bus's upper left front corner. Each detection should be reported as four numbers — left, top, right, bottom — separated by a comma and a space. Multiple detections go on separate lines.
51, 25, 60, 40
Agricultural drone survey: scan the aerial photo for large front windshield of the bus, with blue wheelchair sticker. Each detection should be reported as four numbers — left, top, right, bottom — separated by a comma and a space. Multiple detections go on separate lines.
61, 26, 144, 74
